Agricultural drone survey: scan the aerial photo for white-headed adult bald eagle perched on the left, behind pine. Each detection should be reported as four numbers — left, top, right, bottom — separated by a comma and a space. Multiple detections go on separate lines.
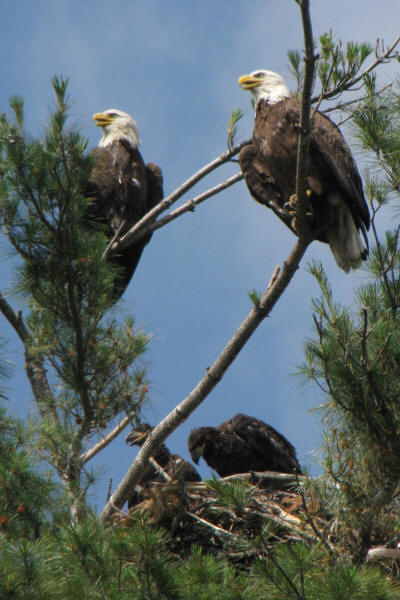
87, 108, 163, 301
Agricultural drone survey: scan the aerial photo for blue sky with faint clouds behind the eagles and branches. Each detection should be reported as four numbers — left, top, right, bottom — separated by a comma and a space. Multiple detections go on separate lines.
0, 0, 400, 506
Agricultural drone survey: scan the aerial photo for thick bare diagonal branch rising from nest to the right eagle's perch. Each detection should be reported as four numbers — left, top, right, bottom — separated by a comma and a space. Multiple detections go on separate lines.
101, 238, 308, 521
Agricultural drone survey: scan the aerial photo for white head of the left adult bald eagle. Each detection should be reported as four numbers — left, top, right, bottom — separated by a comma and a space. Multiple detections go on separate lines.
93, 108, 140, 149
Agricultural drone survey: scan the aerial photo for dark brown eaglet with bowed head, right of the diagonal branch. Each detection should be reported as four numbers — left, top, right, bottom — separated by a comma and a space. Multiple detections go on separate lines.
188, 413, 301, 477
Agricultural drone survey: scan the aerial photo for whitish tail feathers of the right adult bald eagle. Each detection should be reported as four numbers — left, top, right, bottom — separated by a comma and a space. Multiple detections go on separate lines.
326, 194, 365, 273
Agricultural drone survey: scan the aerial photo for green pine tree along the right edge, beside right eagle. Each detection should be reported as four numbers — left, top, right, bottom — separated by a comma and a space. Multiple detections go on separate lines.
303, 77, 400, 560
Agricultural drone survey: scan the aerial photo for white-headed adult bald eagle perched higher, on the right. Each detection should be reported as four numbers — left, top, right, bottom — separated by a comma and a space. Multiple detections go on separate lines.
239, 70, 369, 273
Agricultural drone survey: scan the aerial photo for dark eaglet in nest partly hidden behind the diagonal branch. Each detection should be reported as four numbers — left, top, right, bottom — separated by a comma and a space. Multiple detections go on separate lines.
125, 423, 201, 508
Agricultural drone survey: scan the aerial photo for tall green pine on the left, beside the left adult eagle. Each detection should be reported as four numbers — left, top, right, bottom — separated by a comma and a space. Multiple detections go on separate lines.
0, 78, 149, 514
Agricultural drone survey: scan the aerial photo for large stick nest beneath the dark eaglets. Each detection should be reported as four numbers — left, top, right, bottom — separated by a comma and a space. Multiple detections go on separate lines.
115, 472, 329, 564
